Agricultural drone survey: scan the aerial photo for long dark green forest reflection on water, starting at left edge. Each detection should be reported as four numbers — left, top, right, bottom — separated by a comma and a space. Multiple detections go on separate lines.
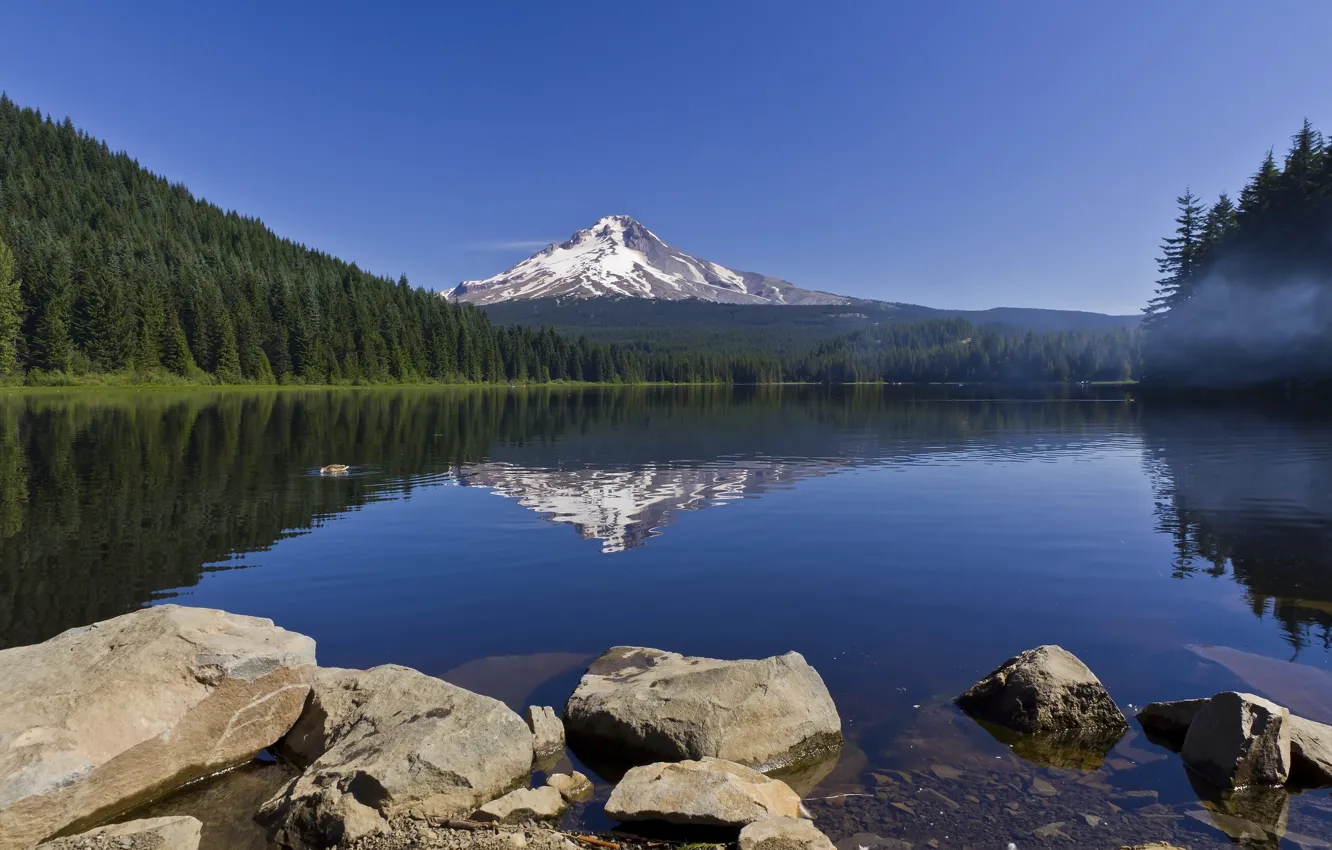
0, 386, 1134, 646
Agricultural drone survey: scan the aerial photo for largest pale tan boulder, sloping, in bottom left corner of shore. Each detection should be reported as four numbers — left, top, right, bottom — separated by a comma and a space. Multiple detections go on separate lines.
0, 605, 314, 847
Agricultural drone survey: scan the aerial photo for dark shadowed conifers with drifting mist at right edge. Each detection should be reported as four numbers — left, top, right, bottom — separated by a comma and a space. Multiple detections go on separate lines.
1144, 121, 1332, 388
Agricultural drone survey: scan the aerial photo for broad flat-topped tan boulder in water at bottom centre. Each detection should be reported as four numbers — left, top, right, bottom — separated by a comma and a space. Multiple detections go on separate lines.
563, 646, 842, 770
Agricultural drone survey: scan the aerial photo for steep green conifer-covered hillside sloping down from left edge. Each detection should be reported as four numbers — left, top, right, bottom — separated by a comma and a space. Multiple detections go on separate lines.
0, 96, 634, 382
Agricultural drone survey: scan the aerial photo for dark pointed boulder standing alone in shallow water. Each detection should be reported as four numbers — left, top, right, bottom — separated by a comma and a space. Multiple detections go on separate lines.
955, 645, 1128, 735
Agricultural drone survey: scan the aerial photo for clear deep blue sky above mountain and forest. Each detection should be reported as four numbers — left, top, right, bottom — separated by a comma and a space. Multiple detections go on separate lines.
0, 0, 1332, 312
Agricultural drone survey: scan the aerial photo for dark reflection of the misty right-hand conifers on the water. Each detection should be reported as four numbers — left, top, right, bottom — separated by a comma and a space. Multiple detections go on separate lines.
1142, 404, 1332, 654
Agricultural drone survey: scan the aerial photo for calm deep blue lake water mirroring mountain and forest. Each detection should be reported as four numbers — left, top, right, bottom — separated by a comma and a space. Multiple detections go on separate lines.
0, 388, 1332, 847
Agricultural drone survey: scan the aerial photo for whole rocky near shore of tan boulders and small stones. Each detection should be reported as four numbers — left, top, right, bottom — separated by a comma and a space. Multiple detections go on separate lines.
0, 605, 1332, 850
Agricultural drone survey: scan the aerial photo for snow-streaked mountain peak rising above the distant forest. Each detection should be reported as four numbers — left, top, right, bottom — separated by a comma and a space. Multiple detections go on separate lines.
445, 216, 855, 304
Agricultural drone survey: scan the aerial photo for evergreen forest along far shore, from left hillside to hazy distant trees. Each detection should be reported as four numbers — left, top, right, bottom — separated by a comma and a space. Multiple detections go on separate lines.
0, 96, 1138, 385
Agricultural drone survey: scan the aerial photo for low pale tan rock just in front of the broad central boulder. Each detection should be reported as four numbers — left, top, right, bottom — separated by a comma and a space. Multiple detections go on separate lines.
606, 758, 803, 827
